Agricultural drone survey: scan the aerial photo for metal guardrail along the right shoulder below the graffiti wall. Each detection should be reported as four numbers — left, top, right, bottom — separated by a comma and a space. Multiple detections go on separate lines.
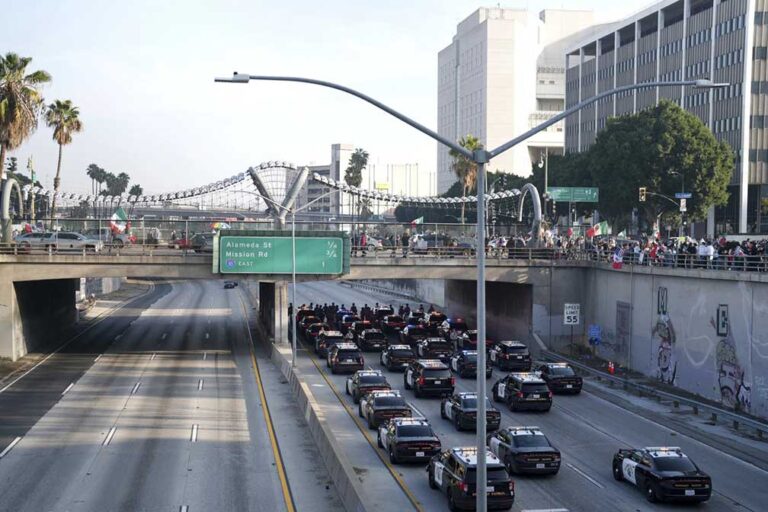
542, 350, 768, 439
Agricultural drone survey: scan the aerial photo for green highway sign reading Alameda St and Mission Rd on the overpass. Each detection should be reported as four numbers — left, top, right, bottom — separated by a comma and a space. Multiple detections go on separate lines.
218, 235, 344, 274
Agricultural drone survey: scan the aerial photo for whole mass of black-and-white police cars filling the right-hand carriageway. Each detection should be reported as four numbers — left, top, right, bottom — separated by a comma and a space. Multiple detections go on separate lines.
296, 307, 712, 510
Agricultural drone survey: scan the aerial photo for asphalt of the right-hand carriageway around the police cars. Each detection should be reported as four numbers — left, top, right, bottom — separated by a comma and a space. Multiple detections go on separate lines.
296, 282, 768, 512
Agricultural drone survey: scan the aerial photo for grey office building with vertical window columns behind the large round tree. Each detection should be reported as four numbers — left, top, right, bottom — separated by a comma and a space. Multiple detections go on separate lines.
565, 0, 768, 234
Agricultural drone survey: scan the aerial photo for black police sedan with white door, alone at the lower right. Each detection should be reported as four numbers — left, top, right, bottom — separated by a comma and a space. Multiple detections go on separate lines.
613, 446, 712, 502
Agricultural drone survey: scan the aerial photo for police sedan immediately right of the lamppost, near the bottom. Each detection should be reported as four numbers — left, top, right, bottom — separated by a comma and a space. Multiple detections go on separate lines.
488, 427, 560, 475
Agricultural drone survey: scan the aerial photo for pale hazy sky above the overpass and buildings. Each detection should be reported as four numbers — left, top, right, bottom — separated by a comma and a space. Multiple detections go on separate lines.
7, 0, 636, 192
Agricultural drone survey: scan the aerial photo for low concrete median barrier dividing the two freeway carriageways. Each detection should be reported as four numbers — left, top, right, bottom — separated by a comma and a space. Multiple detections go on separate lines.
272, 344, 369, 512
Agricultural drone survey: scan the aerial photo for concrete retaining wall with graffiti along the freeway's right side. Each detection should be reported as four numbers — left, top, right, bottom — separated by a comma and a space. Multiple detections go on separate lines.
584, 270, 768, 418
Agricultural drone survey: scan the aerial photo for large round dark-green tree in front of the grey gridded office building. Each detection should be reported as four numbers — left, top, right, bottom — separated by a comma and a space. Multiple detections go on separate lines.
587, 100, 734, 228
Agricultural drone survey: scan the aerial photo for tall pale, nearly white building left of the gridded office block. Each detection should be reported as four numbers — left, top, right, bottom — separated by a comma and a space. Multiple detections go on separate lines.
437, 8, 594, 193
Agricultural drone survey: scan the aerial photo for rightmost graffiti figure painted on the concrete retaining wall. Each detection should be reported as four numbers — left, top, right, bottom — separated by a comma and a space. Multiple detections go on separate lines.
710, 304, 752, 411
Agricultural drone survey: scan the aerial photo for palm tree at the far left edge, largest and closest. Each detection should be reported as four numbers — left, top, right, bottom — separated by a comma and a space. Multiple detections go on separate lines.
0, 52, 51, 181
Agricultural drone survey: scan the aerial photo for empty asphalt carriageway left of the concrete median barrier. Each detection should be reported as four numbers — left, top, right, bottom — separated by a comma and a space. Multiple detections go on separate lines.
0, 281, 339, 512
